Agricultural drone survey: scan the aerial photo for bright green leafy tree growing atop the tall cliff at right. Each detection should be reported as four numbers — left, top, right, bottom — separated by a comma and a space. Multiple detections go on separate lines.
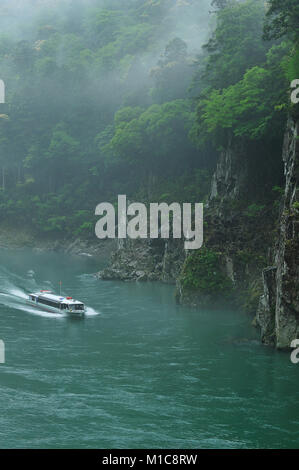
198, 57, 286, 145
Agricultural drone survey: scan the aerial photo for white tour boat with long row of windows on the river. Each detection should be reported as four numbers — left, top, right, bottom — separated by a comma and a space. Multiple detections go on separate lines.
27, 290, 85, 315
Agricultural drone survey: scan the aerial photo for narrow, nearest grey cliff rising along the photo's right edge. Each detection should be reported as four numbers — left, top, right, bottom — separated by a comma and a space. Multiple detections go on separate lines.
257, 119, 299, 349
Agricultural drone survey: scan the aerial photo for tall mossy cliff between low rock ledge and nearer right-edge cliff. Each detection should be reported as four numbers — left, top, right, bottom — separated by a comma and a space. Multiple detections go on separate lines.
177, 142, 273, 313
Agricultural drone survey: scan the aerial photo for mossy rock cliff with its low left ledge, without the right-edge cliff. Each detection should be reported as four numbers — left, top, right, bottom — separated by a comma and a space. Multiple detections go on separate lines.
98, 139, 273, 313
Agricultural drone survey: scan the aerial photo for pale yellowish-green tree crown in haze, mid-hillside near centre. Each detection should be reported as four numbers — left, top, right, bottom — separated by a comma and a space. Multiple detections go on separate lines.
101, 100, 196, 194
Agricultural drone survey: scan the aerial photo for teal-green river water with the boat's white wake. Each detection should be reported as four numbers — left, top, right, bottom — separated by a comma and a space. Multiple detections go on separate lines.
0, 250, 299, 449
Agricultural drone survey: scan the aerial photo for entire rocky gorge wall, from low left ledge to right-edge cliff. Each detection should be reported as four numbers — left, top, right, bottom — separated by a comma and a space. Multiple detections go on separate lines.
98, 119, 299, 348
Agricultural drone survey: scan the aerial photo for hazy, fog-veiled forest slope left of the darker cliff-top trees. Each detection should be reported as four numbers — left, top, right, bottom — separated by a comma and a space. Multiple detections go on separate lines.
0, 0, 215, 237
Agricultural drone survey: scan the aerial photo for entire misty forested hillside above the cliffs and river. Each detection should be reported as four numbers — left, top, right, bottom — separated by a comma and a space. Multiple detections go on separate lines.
0, 0, 298, 236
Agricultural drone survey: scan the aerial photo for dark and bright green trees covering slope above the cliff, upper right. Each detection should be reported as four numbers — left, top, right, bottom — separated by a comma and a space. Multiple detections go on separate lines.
193, 0, 298, 146
